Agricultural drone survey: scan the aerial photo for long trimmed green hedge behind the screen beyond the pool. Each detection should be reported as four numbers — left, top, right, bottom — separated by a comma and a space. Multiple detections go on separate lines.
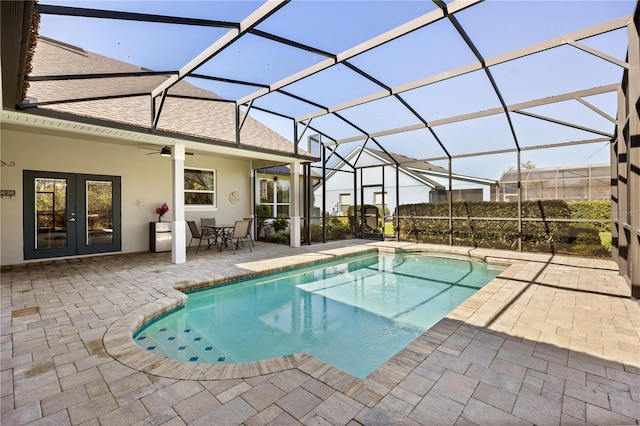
395, 200, 611, 256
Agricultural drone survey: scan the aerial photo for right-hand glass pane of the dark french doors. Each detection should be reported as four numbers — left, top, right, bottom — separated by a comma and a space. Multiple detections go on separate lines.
86, 180, 113, 245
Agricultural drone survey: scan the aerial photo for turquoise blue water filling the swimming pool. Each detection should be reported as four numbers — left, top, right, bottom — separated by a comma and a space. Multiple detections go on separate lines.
134, 253, 504, 378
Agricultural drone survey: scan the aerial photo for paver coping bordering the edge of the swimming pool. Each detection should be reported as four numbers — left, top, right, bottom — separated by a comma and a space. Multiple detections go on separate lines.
103, 245, 527, 407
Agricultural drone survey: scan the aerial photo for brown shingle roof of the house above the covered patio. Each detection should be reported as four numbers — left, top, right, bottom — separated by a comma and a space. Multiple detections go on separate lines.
22, 37, 306, 155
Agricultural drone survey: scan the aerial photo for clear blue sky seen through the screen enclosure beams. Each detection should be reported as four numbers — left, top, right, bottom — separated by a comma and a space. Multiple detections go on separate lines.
40, 0, 636, 179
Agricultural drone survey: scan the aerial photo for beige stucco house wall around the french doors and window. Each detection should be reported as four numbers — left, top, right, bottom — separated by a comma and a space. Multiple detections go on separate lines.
0, 123, 252, 265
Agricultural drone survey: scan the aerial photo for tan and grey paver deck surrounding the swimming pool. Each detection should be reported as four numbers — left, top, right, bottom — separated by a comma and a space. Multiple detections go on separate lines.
0, 240, 640, 426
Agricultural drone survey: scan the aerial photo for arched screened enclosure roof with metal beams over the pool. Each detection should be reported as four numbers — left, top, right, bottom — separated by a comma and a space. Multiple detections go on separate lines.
5, 0, 636, 179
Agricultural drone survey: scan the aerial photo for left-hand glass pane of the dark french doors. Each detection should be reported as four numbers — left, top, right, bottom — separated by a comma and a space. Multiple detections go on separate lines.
35, 178, 67, 249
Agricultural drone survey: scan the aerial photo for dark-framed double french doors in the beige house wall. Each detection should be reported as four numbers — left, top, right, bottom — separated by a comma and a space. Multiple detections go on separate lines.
23, 170, 121, 260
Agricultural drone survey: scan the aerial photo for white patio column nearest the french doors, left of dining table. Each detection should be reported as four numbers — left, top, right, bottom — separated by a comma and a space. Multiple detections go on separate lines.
171, 145, 187, 264
